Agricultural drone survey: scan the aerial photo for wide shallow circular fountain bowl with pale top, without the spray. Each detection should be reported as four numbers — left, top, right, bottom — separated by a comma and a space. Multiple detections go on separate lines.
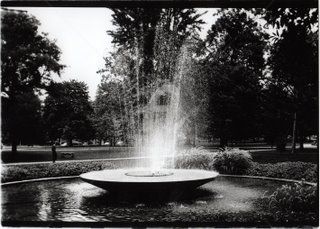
80, 169, 219, 195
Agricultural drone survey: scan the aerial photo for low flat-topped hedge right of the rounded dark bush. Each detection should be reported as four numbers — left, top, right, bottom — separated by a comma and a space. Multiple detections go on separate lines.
247, 162, 318, 182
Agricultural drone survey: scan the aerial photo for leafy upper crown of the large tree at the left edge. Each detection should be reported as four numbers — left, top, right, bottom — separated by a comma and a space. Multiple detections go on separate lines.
1, 10, 63, 93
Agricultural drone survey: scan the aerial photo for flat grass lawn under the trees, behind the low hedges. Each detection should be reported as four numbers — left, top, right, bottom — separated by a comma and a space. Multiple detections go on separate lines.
1, 146, 319, 164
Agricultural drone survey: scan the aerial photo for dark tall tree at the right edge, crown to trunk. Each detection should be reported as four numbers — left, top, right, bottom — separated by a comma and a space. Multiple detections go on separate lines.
263, 8, 318, 152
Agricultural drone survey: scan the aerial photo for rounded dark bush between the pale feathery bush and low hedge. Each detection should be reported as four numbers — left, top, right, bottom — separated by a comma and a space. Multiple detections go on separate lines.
214, 149, 252, 175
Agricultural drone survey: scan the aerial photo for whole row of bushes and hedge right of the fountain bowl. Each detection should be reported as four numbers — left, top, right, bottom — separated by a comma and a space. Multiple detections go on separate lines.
175, 147, 318, 182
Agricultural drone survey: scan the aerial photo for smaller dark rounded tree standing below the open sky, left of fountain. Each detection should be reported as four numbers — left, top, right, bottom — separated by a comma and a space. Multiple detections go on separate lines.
43, 80, 94, 145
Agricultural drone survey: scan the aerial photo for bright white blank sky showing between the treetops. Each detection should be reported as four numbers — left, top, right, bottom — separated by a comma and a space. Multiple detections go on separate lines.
7, 7, 216, 100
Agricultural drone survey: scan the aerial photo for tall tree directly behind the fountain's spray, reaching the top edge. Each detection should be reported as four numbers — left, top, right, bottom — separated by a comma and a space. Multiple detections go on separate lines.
100, 8, 202, 143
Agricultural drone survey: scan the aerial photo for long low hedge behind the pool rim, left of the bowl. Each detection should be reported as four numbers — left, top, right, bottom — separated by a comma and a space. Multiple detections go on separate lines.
1, 161, 116, 182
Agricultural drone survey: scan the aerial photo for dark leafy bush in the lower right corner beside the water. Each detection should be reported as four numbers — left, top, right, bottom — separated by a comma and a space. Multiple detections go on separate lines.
263, 183, 318, 223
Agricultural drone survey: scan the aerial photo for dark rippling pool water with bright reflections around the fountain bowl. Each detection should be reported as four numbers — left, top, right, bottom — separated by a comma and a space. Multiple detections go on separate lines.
2, 177, 285, 222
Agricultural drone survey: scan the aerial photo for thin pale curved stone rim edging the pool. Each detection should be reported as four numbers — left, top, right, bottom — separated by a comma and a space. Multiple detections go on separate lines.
1, 174, 317, 186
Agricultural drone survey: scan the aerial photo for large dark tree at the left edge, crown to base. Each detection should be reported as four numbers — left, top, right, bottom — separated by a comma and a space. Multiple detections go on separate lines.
1, 10, 63, 152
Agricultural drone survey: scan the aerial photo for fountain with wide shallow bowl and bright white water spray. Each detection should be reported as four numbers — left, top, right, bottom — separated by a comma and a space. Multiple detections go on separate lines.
80, 46, 218, 197
